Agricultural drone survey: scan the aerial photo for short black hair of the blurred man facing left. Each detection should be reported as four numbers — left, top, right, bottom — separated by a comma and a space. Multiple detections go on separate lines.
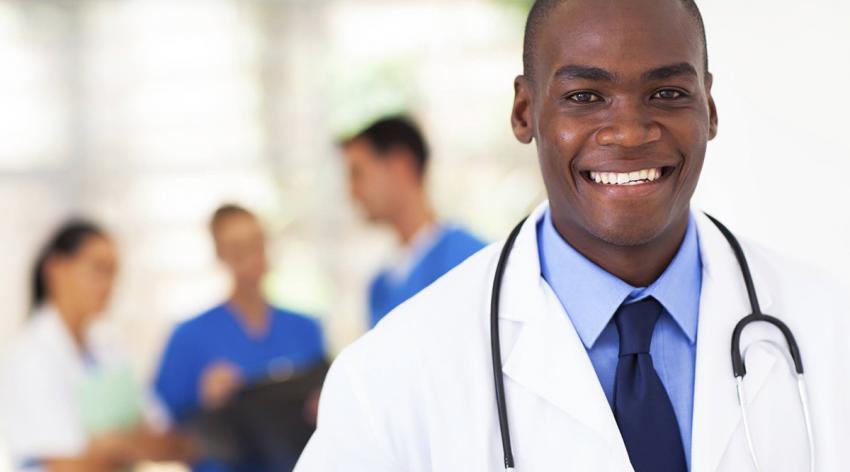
342, 116, 428, 177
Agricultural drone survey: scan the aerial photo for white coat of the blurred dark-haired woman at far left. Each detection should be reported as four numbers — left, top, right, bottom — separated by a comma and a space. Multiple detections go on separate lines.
0, 305, 149, 471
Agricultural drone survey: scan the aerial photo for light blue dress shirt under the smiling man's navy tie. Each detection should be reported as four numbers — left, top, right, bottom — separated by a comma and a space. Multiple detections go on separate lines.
537, 210, 702, 467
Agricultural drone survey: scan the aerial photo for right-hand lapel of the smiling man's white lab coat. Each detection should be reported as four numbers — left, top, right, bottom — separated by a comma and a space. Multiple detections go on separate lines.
691, 214, 777, 472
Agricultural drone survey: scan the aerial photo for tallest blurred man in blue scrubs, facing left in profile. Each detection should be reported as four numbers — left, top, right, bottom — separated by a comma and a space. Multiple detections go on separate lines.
342, 117, 484, 327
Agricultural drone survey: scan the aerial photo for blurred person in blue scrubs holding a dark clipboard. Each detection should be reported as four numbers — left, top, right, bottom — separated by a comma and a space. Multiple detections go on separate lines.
156, 205, 325, 472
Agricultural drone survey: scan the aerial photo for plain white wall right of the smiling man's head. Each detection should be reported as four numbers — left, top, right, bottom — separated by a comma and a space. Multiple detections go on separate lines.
697, 0, 850, 284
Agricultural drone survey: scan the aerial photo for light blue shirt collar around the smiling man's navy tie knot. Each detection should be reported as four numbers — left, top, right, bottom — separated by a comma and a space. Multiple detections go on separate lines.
537, 209, 702, 348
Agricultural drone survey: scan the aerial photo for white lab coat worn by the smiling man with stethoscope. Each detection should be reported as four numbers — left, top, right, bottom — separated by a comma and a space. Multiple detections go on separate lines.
296, 205, 850, 472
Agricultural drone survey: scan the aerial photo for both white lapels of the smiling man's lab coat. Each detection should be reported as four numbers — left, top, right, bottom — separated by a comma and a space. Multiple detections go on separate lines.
499, 203, 776, 472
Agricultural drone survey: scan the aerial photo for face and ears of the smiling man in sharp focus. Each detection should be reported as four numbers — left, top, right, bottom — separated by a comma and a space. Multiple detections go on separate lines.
513, 0, 717, 246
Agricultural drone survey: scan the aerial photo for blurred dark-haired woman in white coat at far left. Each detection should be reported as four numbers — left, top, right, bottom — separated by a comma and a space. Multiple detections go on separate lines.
0, 220, 188, 472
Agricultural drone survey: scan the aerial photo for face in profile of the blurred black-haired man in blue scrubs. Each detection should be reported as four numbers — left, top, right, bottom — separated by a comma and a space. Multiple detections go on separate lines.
343, 139, 400, 222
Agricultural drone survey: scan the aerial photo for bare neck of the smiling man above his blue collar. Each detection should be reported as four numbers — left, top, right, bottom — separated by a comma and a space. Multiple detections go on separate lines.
553, 213, 689, 287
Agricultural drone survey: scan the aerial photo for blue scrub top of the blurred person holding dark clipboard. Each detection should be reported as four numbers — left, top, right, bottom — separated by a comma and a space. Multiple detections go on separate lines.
155, 304, 325, 472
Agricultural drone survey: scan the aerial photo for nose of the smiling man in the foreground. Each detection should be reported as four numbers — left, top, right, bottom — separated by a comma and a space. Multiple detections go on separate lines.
596, 102, 662, 147
